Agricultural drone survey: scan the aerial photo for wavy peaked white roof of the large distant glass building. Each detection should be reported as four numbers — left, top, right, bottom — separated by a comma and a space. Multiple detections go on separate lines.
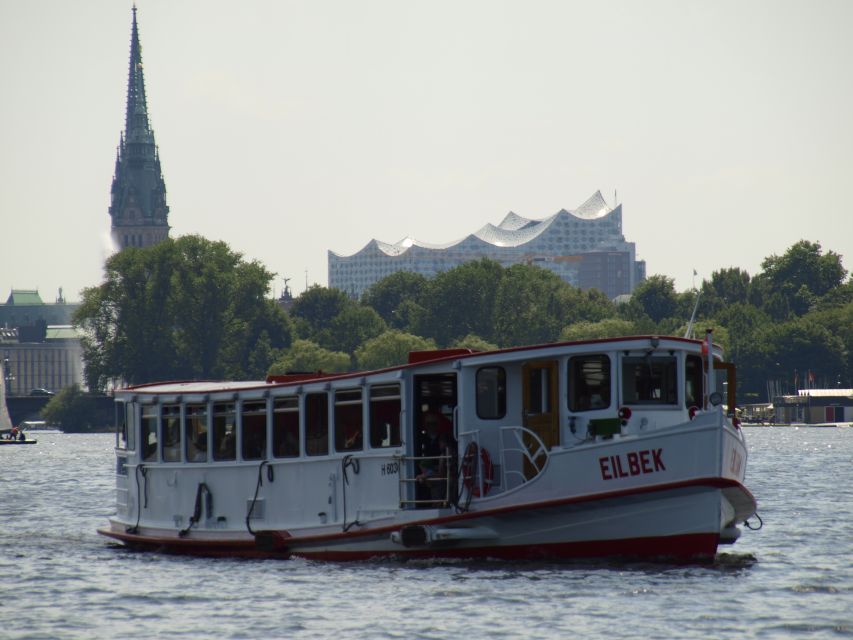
329, 191, 613, 258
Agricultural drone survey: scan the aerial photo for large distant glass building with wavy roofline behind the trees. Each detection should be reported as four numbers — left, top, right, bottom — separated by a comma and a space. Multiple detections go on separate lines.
329, 191, 646, 299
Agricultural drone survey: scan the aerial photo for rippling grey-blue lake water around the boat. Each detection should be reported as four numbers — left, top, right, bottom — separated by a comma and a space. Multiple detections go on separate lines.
0, 427, 853, 639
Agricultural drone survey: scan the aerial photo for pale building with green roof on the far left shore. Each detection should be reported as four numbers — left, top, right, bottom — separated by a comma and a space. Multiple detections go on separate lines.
0, 289, 83, 396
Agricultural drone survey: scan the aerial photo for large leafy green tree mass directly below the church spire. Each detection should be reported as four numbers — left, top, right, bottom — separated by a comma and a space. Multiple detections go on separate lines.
74, 236, 291, 389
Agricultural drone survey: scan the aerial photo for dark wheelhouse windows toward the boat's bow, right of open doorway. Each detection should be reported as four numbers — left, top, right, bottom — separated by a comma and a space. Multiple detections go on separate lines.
476, 354, 703, 420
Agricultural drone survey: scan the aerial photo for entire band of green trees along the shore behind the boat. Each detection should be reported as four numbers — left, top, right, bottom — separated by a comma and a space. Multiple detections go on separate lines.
74, 236, 853, 402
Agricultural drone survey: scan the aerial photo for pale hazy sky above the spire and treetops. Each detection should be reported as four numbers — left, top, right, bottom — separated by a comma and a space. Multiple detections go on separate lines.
0, 0, 853, 302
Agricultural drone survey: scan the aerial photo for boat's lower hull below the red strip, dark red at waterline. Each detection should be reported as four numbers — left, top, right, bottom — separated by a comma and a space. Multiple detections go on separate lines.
99, 479, 752, 562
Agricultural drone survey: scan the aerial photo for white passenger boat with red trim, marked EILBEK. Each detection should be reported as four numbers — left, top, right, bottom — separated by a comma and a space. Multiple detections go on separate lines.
99, 333, 756, 560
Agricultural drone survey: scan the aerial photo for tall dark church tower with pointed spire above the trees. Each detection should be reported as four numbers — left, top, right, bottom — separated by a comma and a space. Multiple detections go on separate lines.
110, 5, 169, 249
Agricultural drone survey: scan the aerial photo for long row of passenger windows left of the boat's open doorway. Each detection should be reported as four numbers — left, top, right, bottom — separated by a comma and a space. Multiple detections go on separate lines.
117, 384, 402, 462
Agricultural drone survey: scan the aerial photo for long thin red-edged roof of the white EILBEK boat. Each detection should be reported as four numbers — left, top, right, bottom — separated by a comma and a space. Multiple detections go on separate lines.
116, 335, 722, 396
